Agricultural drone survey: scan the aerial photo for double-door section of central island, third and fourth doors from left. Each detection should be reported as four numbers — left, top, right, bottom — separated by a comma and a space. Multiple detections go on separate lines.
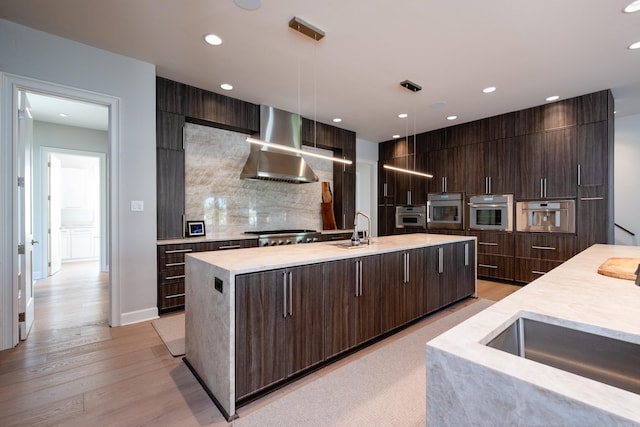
323, 255, 381, 358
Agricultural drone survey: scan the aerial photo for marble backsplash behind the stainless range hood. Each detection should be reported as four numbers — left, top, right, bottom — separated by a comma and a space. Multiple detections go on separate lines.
183, 123, 333, 234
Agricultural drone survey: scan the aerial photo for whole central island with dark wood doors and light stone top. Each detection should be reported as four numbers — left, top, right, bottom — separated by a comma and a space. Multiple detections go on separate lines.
185, 234, 476, 419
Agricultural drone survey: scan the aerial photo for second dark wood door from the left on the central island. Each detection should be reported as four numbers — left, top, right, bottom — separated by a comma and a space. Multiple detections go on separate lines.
286, 264, 324, 376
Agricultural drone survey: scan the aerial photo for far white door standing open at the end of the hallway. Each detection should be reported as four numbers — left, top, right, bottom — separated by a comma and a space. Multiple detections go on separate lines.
47, 153, 62, 276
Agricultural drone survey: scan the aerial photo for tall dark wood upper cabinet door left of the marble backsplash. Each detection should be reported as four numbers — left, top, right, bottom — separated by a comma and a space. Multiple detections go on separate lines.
156, 148, 185, 239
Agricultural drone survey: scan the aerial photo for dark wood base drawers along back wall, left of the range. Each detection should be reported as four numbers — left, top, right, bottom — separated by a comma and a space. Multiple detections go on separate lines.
157, 239, 258, 314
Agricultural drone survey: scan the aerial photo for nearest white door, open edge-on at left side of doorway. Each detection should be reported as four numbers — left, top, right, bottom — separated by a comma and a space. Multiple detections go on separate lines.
16, 91, 37, 340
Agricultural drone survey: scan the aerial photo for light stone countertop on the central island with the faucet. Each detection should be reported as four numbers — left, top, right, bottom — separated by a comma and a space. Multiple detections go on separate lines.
188, 233, 475, 274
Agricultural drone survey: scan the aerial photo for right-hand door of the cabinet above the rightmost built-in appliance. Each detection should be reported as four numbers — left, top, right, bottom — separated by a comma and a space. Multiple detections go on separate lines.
544, 127, 577, 198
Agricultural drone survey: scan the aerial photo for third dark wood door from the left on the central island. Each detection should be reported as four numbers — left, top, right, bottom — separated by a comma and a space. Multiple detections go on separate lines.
323, 259, 359, 358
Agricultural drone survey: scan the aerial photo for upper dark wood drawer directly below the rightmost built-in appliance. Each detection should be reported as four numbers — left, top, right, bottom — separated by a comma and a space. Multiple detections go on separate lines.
516, 233, 576, 261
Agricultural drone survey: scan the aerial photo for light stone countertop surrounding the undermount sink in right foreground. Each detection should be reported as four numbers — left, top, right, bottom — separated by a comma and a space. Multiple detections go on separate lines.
427, 245, 640, 425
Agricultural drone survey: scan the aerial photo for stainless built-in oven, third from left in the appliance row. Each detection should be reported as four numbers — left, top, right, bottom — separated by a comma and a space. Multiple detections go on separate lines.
469, 194, 513, 231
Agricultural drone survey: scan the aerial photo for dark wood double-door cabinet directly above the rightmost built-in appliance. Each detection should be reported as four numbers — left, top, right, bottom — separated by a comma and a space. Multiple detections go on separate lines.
516, 127, 577, 200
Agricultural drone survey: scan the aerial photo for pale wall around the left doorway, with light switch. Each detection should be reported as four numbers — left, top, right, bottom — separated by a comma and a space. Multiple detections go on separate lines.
0, 20, 157, 334
